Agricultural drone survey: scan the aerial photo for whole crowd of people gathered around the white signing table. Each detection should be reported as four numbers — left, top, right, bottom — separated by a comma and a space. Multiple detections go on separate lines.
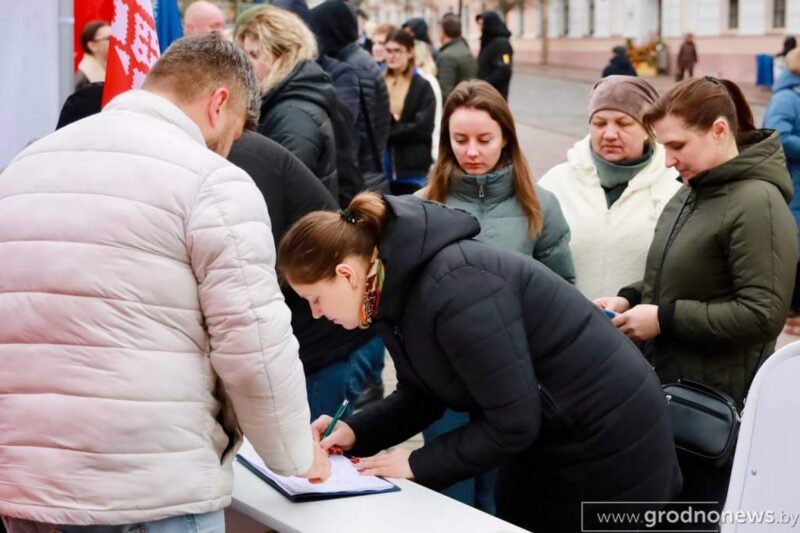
0, 0, 800, 533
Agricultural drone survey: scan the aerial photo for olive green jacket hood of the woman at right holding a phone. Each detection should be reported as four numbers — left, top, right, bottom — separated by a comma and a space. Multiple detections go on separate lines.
689, 130, 792, 202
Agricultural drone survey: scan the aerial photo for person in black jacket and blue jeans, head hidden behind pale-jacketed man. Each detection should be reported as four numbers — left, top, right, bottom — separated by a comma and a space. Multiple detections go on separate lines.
228, 132, 373, 419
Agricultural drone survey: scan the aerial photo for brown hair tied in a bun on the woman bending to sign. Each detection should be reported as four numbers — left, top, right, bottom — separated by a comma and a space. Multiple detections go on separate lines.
278, 192, 387, 285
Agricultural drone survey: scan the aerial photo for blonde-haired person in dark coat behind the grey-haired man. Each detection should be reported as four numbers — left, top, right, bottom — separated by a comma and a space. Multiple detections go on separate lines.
234, 6, 339, 198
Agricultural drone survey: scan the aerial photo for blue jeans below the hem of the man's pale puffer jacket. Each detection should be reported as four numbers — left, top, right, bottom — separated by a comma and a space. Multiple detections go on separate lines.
3, 509, 225, 533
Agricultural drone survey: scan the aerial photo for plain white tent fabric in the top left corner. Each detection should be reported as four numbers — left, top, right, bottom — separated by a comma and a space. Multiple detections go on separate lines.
0, 0, 63, 169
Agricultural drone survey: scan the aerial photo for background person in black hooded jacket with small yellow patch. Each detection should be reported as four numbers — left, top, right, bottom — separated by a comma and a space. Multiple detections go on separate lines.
476, 11, 514, 100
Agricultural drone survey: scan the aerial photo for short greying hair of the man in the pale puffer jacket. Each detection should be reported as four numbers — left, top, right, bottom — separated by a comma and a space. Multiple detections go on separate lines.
142, 32, 261, 128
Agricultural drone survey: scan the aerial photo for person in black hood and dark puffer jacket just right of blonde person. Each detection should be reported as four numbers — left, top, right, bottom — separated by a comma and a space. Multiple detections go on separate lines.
311, 0, 390, 192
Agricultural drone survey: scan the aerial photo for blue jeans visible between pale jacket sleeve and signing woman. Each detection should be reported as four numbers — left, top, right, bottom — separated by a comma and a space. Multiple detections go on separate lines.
306, 337, 383, 420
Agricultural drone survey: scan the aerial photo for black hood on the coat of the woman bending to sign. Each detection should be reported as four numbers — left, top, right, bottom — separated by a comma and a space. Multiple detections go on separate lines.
378, 196, 481, 320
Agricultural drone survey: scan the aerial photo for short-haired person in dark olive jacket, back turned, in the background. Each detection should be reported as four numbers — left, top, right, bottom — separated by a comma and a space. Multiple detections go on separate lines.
436, 14, 478, 101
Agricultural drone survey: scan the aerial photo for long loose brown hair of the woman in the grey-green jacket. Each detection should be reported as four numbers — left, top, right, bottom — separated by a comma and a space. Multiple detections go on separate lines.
425, 80, 544, 236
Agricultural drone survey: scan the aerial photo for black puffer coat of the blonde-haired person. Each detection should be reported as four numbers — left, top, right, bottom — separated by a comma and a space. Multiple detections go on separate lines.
258, 61, 339, 198
